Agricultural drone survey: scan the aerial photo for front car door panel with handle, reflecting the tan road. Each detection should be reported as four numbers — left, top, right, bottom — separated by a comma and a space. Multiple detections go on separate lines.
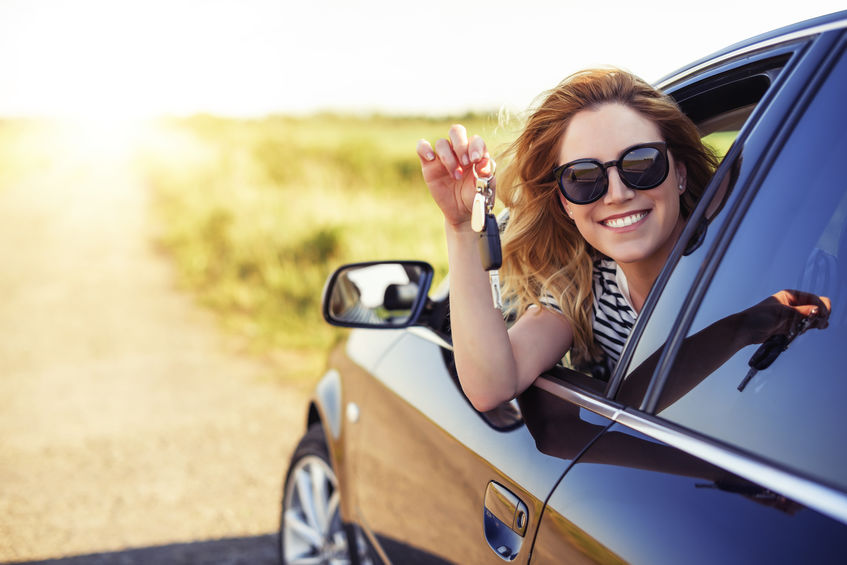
347, 310, 610, 563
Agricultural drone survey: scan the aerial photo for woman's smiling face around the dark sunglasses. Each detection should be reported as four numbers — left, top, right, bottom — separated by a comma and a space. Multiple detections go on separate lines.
558, 103, 685, 266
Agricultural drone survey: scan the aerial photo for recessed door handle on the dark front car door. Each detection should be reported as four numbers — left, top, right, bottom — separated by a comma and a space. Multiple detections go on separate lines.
483, 481, 528, 561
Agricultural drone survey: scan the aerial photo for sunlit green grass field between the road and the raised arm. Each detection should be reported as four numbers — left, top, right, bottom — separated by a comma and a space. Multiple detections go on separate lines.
138, 115, 513, 376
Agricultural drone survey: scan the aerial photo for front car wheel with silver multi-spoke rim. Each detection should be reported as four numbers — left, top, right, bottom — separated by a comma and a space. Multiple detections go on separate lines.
279, 424, 368, 565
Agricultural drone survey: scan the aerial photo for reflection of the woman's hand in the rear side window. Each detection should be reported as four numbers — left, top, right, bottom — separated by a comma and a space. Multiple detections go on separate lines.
742, 290, 831, 343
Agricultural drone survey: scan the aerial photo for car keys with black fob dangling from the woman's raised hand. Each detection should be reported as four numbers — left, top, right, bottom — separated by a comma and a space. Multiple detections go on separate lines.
471, 161, 503, 310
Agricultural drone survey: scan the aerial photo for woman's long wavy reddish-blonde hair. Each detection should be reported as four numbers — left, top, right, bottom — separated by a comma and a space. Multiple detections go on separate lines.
497, 69, 717, 365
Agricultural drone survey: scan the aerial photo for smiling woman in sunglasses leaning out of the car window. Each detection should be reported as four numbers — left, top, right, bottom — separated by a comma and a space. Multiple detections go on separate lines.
417, 70, 820, 411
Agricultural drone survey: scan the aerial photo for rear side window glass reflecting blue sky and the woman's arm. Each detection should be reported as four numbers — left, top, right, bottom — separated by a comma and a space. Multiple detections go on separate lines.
657, 46, 847, 488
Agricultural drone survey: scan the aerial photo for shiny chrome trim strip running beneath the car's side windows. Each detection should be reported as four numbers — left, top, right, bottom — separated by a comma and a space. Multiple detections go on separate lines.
535, 376, 847, 524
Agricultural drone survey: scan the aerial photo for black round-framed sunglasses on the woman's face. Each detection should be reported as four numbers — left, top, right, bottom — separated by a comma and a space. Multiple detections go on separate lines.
553, 141, 670, 204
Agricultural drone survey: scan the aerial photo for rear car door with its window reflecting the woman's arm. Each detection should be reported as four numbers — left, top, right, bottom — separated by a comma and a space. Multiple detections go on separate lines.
532, 20, 847, 563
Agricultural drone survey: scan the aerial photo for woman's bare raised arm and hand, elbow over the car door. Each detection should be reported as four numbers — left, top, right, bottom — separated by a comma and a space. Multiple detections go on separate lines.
418, 125, 573, 411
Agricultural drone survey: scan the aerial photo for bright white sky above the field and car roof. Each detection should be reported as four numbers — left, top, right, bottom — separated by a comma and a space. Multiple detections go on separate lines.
0, 0, 845, 118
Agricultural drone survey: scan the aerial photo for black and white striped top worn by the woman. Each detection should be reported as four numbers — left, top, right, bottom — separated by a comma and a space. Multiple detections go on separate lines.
541, 259, 637, 368
